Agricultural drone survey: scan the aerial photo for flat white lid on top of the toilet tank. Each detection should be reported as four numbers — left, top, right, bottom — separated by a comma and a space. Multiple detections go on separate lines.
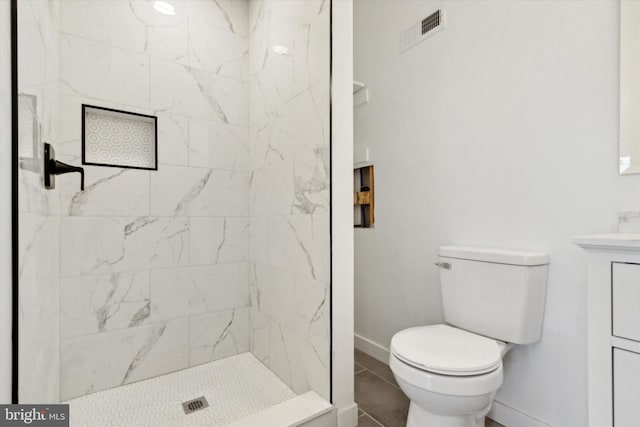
439, 246, 549, 266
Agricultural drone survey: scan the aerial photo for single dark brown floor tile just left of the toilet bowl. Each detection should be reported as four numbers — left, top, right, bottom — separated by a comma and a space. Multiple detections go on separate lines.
355, 371, 409, 427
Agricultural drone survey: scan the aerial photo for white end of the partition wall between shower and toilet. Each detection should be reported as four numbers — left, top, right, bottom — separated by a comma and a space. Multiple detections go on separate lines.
331, 0, 358, 427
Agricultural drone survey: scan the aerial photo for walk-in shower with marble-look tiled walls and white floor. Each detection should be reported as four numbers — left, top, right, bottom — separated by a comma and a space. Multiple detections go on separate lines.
14, 0, 331, 426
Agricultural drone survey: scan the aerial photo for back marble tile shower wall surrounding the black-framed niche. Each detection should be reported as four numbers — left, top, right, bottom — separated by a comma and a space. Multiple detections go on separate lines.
18, 0, 250, 401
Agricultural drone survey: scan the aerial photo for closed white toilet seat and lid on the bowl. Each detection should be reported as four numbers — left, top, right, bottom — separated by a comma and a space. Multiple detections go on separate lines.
391, 325, 506, 376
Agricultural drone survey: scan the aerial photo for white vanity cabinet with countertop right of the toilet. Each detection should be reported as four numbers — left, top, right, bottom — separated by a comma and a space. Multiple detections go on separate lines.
574, 233, 640, 427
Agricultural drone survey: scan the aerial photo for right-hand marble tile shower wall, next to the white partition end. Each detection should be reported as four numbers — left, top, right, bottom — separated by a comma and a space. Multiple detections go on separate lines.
249, 0, 330, 399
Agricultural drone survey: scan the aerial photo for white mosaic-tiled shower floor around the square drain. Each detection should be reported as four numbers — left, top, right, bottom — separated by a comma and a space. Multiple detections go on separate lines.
65, 353, 296, 427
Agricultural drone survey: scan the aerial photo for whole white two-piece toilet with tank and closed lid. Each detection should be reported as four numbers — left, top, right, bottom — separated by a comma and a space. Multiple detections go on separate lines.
389, 246, 549, 427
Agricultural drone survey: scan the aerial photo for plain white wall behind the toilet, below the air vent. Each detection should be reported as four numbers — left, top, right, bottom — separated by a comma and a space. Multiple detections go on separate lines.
354, 0, 640, 426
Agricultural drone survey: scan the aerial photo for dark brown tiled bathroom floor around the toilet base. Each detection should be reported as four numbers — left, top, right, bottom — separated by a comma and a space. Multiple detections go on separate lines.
354, 350, 504, 427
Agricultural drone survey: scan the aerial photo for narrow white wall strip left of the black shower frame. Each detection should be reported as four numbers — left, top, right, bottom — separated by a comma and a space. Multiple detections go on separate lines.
0, 0, 11, 403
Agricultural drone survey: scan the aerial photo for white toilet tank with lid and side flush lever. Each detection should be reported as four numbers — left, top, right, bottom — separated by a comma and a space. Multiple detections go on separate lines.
438, 246, 549, 344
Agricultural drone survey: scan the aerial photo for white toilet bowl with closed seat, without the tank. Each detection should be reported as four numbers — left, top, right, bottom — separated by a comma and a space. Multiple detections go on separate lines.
389, 325, 512, 427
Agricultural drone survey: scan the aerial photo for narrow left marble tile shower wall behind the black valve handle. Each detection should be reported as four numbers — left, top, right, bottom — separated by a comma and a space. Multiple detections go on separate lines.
18, 0, 60, 402
